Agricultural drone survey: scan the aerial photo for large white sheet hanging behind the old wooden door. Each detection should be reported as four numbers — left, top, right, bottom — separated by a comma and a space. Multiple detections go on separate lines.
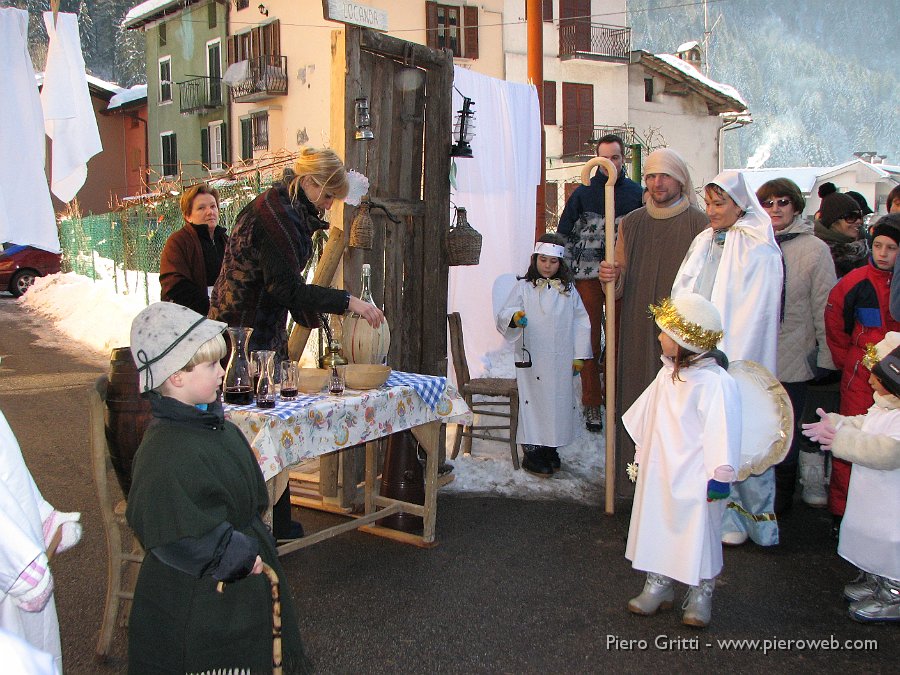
447, 66, 541, 377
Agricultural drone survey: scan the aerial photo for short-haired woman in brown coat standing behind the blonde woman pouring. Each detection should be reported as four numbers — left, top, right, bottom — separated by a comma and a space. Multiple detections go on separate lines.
159, 183, 228, 316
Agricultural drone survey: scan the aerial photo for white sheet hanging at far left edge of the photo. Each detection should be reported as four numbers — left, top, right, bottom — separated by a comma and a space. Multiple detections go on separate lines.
0, 7, 59, 252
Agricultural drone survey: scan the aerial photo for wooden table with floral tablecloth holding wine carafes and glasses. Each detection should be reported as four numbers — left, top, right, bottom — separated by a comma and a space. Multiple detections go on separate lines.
225, 376, 472, 555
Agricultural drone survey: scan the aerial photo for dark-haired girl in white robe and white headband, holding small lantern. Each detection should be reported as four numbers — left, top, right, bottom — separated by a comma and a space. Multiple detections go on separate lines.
496, 234, 592, 477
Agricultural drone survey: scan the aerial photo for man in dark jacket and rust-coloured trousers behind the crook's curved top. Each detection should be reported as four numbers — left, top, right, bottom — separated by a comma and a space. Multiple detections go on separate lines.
557, 134, 642, 431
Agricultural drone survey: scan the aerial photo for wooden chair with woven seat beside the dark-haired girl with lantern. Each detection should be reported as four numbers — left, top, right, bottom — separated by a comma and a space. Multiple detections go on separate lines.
447, 312, 519, 469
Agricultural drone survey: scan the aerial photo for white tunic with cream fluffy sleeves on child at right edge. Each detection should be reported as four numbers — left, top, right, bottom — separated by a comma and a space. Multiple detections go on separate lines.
828, 402, 900, 581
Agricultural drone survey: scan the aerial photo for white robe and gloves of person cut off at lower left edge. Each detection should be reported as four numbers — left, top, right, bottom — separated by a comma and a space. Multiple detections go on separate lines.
0, 412, 81, 672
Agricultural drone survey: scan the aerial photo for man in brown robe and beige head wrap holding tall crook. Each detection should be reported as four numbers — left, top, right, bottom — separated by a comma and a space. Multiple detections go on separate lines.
598, 148, 709, 498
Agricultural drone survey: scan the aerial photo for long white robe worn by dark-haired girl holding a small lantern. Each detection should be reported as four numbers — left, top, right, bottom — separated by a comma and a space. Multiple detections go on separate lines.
496, 272, 592, 448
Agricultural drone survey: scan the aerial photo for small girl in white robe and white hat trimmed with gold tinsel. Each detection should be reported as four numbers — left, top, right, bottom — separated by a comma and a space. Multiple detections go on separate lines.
622, 293, 741, 627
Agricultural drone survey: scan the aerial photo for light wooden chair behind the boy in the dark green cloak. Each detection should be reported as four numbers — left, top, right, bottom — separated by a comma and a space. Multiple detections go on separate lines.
88, 375, 144, 660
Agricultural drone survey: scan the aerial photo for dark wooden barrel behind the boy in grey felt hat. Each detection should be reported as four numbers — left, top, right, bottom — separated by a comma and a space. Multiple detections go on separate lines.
106, 347, 153, 497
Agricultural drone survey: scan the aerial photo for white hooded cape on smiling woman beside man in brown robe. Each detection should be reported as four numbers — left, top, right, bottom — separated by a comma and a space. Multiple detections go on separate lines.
672, 171, 784, 373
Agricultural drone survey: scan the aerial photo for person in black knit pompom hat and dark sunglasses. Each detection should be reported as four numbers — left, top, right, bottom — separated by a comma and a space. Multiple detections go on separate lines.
815, 183, 869, 279
